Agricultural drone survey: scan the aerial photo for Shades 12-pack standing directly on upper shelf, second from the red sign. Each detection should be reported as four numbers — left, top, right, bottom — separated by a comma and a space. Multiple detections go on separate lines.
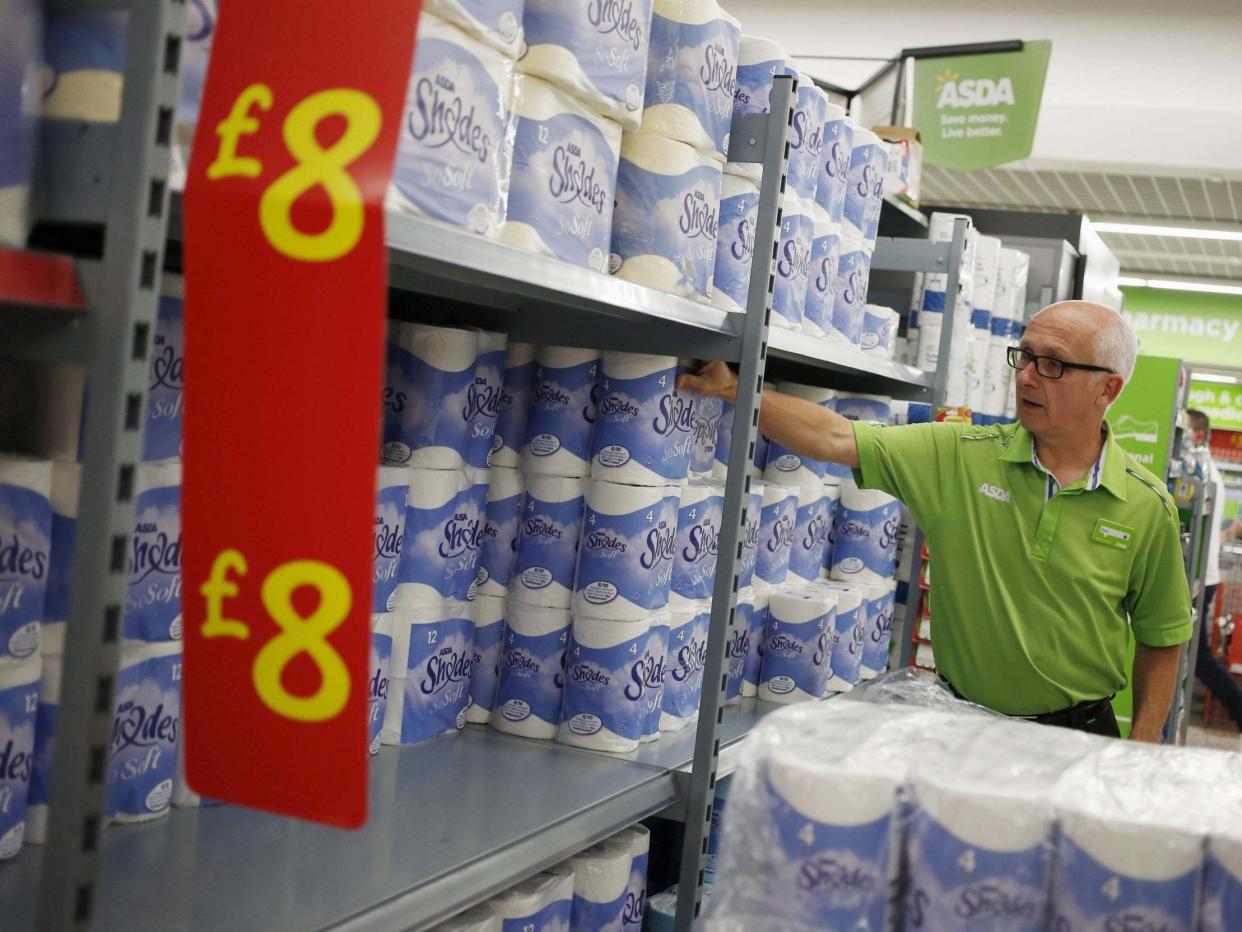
499, 75, 621, 272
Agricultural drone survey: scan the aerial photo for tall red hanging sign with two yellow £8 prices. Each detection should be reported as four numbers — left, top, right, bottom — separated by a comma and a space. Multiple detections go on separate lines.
181, 0, 419, 826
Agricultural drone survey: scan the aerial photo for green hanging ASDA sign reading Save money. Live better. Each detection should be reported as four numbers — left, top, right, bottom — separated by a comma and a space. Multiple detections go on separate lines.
914, 40, 1052, 171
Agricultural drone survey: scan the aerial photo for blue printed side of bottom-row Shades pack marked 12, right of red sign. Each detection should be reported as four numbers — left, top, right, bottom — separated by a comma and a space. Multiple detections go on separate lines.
401, 618, 474, 744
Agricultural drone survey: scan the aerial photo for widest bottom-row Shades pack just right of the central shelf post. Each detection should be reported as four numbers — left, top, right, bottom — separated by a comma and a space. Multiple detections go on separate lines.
759, 587, 837, 703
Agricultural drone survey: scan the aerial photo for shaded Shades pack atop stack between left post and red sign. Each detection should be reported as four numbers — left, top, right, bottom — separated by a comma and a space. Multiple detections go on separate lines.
143, 284, 185, 462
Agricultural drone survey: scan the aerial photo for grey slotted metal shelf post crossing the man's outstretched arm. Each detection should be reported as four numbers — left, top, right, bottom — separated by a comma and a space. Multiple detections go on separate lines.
674, 76, 796, 932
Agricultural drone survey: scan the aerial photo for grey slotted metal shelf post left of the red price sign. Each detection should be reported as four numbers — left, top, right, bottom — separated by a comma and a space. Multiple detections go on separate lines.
37, 0, 185, 931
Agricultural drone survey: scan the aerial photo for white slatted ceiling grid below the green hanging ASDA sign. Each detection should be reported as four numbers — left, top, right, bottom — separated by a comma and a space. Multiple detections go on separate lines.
922, 165, 1242, 281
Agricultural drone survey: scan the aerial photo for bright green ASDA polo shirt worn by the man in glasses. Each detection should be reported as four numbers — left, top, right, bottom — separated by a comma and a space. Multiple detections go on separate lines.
854, 421, 1192, 715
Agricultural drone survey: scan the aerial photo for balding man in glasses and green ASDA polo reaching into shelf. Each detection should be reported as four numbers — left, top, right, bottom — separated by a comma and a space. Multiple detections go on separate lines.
678, 301, 1194, 742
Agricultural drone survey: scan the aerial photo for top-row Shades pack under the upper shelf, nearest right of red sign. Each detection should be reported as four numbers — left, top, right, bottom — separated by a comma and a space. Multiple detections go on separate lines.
384, 321, 478, 470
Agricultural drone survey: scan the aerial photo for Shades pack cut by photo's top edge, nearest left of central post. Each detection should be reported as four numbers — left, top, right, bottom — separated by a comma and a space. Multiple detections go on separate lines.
640, 0, 741, 163
